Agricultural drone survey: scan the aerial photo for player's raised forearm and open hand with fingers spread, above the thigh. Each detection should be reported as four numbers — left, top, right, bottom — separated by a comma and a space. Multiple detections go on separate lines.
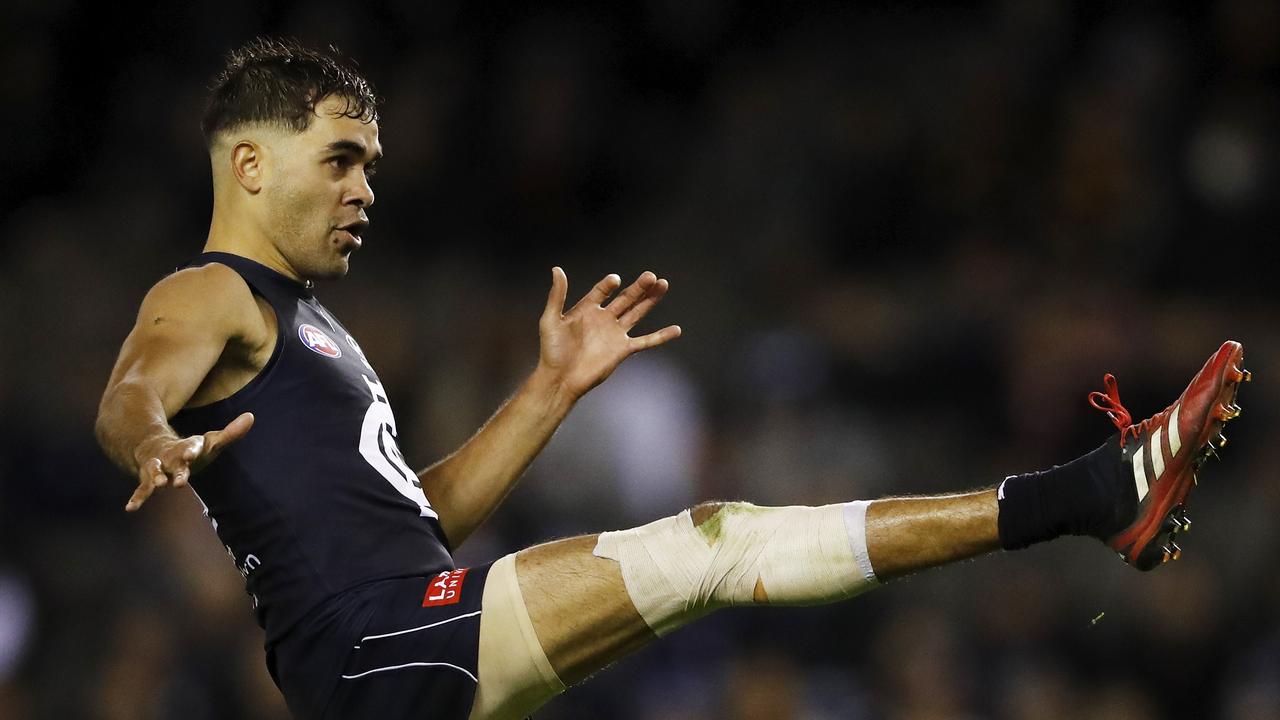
419, 268, 680, 547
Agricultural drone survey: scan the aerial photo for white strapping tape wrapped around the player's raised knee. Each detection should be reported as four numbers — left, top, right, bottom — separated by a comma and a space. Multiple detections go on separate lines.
594, 502, 877, 635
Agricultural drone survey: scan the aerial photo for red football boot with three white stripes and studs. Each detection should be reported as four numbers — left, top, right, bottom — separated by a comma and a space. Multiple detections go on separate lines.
1089, 341, 1252, 570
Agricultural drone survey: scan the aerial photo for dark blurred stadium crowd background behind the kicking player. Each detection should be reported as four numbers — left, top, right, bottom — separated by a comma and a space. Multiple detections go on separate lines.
0, 0, 1280, 720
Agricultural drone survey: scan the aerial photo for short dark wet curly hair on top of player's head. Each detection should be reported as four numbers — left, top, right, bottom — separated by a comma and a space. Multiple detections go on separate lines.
200, 37, 379, 147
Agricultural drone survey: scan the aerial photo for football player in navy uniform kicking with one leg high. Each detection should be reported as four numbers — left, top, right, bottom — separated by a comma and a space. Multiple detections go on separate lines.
96, 40, 1249, 720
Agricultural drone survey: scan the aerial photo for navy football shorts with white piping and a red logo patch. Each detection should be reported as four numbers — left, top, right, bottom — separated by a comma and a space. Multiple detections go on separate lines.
268, 565, 489, 720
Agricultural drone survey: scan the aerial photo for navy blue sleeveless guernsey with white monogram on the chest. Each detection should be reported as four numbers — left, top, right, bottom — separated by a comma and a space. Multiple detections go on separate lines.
170, 252, 453, 647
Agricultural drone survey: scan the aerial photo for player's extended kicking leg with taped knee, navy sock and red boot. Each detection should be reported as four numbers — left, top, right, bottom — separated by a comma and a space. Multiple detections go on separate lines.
472, 342, 1251, 720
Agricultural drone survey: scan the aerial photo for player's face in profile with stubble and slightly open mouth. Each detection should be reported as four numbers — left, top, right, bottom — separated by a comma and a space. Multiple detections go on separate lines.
262, 96, 383, 279
